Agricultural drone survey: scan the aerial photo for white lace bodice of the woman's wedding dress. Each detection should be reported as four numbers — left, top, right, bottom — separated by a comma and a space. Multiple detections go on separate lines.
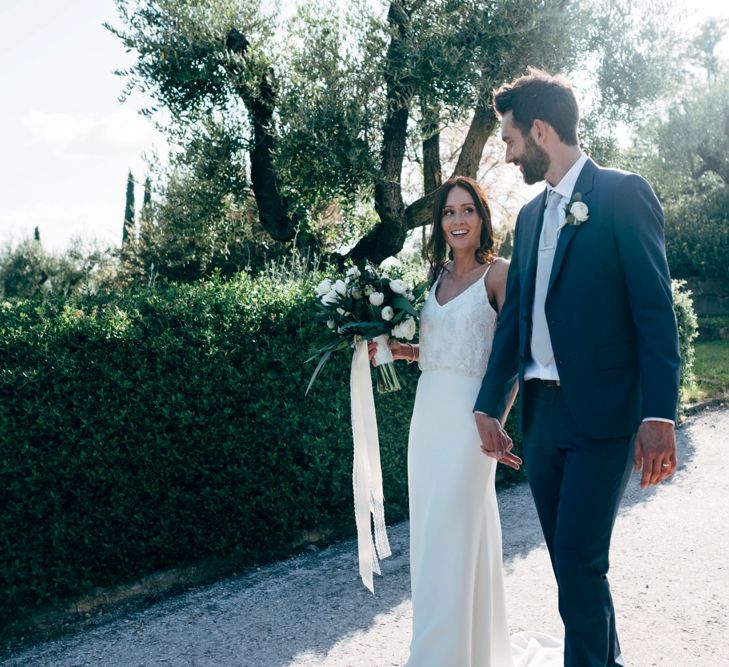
419, 267, 496, 378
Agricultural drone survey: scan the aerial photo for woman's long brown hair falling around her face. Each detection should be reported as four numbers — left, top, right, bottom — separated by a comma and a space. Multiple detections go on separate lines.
426, 176, 496, 287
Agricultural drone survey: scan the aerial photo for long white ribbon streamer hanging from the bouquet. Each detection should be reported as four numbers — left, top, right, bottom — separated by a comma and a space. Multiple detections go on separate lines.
349, 337, 391, 593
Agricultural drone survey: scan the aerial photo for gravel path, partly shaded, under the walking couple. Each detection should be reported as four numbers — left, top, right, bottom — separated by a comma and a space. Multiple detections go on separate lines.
0, 409, 729, 667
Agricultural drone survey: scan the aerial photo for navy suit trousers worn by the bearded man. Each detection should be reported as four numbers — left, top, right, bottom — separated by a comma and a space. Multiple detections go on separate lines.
522, 380, 632, 667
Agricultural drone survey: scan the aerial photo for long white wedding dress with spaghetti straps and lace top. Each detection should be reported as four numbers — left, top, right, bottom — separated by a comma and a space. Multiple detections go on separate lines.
407, 268, 562, 667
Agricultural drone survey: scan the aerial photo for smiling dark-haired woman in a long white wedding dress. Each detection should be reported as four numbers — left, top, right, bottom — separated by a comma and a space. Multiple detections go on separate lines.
369, 176, 561, 667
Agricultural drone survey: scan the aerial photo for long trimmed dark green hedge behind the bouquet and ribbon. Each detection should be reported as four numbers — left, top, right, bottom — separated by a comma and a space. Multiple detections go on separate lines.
0, 276, 690, 626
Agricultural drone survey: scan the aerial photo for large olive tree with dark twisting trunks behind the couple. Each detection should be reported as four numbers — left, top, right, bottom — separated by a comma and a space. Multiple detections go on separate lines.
107, 0, 670, 271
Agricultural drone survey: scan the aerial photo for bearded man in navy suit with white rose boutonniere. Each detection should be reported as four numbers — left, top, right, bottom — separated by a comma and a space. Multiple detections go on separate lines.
474, 70, 679, 667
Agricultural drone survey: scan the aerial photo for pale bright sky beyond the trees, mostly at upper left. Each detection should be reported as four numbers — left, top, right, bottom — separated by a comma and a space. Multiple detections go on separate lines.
0, 0, 729, 250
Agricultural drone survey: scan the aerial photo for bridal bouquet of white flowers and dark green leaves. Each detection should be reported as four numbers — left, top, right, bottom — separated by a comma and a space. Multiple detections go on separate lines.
306, 264, 426, 393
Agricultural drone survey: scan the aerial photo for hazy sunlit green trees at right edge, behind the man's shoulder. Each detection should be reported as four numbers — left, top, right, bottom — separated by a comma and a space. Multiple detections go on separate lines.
624, 37, 729, 279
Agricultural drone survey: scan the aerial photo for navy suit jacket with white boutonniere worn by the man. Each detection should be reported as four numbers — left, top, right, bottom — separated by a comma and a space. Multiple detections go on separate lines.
474, 160, 680, 439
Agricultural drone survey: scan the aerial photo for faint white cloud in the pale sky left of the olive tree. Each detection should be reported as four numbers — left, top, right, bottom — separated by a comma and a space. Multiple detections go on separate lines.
23, 108, 164, 157
